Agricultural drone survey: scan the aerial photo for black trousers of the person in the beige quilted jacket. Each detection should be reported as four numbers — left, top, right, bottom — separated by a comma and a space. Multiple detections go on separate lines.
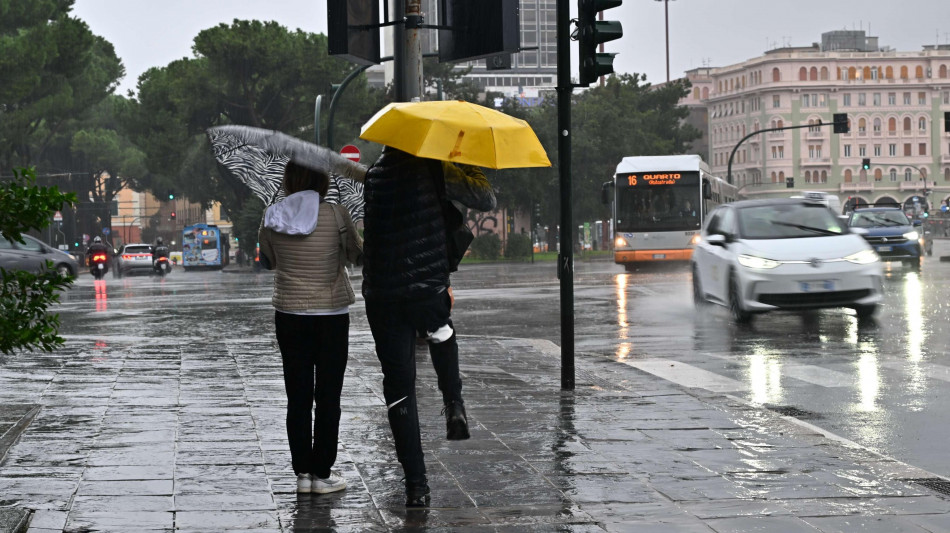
274, 311, 350, 478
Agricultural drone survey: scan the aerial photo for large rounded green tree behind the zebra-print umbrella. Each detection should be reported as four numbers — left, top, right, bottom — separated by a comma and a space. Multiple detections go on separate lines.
128, 20, 384, 219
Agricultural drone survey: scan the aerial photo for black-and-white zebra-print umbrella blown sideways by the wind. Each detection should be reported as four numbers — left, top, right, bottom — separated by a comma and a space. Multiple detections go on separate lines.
208, 126, 366, 222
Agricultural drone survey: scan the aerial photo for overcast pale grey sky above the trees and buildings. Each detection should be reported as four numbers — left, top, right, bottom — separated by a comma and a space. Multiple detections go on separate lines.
73, 0, 950, 94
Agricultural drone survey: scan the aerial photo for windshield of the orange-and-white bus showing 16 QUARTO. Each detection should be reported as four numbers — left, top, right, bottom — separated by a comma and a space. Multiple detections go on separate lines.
616, 168, 702, 232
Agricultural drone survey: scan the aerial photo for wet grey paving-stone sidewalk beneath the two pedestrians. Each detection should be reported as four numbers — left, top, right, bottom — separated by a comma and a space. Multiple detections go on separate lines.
0, 331, 950, 532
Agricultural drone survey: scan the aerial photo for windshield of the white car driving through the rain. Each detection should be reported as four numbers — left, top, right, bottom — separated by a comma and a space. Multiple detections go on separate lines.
738, 203, 845, 239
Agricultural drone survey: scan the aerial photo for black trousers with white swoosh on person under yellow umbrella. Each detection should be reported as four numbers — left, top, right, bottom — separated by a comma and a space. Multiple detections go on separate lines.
366, 292, 462, 481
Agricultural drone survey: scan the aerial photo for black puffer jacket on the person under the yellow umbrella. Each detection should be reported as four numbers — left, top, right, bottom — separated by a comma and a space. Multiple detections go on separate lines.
363, 148, 449, 301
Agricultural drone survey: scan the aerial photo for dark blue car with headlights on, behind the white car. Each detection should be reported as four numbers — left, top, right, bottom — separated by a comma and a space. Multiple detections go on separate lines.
848, 207, 923, 270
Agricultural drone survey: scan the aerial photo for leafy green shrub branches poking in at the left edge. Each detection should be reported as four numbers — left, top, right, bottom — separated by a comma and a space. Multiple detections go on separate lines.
0, 168, 76, 354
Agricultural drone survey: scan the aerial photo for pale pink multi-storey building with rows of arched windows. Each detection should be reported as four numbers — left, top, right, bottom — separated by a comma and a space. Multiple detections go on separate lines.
704, 31, 950, 210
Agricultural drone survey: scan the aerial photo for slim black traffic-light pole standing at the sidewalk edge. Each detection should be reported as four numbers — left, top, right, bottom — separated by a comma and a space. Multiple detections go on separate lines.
557, 0, 574, 390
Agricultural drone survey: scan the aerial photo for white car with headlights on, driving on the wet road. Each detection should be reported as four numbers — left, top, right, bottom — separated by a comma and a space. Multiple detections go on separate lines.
691, 198, 884, 322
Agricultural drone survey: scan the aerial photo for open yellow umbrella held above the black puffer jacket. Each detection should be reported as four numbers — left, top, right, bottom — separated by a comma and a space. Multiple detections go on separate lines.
360, 100, 551, 168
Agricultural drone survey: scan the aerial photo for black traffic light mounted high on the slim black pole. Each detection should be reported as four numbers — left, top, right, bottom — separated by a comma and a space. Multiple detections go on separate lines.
577, 0, 623, 85
